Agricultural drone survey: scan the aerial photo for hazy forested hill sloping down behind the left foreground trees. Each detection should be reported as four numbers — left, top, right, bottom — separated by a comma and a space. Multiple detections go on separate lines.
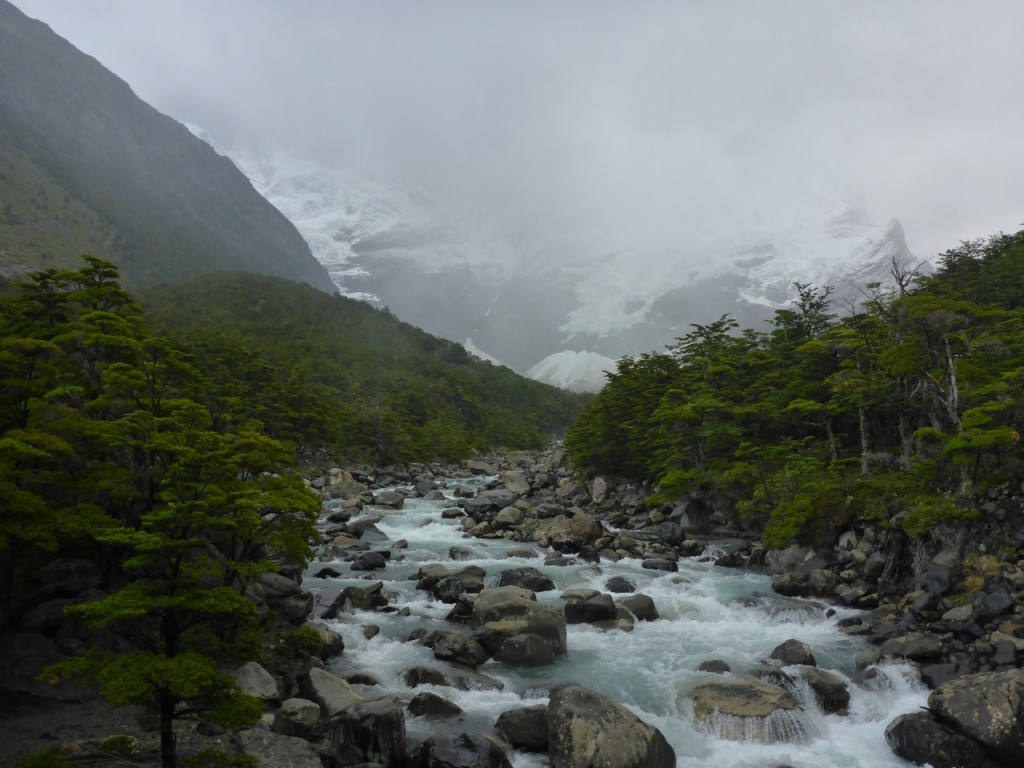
140, 272, 588, 463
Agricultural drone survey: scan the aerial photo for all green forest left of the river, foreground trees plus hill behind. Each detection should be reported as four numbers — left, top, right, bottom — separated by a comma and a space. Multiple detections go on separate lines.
0, 256, 583, 765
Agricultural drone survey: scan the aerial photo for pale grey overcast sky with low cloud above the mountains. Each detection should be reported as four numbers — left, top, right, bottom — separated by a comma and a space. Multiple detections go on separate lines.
14, 0, 1024, 257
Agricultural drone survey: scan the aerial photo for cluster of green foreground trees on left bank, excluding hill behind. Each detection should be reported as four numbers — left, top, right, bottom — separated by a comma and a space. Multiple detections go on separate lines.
0, 256, 319, 768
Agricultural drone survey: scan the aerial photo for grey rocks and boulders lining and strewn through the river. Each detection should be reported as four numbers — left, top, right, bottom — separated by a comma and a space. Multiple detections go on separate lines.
0, 451, 1024, 768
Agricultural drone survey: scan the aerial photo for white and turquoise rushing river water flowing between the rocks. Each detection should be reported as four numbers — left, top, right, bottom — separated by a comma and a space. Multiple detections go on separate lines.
305, 480, 927, 768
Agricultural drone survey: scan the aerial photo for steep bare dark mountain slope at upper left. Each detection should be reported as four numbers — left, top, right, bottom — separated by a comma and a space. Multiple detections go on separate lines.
0, 0, 336, 292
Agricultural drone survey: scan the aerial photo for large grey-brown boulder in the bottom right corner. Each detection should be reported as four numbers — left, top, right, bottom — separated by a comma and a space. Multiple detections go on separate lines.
928, 669, 1024, 765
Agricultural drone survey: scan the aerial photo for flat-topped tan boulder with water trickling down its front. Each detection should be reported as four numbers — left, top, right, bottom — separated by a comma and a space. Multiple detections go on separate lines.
690, 675, 809, 743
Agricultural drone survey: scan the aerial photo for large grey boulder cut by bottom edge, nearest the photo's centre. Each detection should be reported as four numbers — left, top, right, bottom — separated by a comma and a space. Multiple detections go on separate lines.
548, 685, 676, 768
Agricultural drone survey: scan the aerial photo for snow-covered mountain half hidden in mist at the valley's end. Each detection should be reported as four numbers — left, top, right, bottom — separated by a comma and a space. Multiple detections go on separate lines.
194, 129, 913, 389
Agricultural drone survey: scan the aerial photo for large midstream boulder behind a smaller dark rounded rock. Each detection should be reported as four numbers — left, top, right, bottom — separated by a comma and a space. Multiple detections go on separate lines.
470, 587, 566, 654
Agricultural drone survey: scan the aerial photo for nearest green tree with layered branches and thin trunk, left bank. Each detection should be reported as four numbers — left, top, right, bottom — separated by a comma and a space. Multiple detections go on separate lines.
53, 401, 318, 768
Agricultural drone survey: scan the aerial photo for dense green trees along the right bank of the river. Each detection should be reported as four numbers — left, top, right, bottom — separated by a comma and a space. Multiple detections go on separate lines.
566, 231, 1024, 547
